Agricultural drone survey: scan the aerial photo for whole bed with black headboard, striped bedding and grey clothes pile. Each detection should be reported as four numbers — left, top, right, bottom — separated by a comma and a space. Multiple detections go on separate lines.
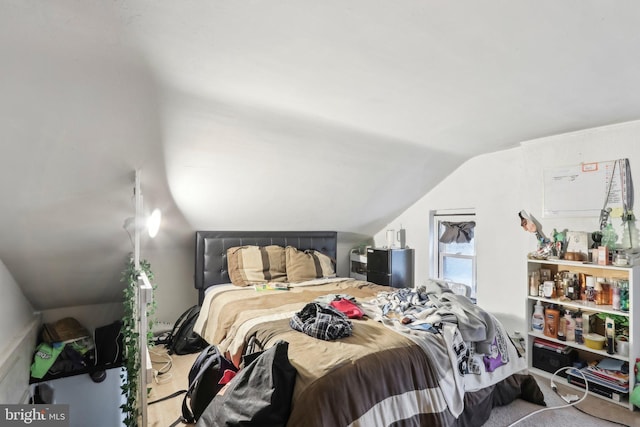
194, 231, 542, 427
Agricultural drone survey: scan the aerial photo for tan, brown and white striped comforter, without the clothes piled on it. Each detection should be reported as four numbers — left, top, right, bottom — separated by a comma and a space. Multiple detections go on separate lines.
194, 279, 524, 427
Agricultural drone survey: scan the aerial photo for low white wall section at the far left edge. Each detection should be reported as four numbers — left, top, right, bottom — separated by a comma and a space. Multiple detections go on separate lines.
0, 260, 40, 403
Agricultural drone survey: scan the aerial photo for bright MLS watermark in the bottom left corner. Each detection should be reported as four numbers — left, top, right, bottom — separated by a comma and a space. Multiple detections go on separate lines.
0, 404, 69, 427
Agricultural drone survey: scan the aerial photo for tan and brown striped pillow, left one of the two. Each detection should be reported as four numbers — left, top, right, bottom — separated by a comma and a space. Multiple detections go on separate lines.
227, 245, 287, 286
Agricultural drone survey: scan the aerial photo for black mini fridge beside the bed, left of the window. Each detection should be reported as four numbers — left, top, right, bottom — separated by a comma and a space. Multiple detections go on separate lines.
367, 248, 414, 288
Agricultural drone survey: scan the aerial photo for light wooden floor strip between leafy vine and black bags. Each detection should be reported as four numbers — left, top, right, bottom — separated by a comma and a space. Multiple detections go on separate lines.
147, 346, 198, 427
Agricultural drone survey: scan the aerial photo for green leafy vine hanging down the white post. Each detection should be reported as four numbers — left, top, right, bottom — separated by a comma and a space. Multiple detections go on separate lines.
120, 259, 156, 427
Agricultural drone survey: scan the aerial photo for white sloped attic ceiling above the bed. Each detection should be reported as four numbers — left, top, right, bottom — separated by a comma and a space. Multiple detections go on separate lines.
0, 0, 640, 309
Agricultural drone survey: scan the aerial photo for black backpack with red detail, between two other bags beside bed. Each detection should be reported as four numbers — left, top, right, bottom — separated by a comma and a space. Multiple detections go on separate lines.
182, 345, 237, 423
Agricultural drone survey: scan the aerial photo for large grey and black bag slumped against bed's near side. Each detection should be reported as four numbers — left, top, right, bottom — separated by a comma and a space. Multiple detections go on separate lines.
196, 341, 297, 427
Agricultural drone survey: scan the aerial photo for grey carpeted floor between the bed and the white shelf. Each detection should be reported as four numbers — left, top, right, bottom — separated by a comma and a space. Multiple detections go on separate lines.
483, 377, 640, 427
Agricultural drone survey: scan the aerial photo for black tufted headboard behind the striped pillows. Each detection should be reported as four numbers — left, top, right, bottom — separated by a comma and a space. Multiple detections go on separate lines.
195, 231, 338, 304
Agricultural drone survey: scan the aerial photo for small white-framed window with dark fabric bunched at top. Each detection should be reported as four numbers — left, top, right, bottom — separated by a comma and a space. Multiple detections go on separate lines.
431, 212, 476, 301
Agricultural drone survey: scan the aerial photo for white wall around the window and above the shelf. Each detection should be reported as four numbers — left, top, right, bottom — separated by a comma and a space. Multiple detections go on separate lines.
374, 121, 640, 331
